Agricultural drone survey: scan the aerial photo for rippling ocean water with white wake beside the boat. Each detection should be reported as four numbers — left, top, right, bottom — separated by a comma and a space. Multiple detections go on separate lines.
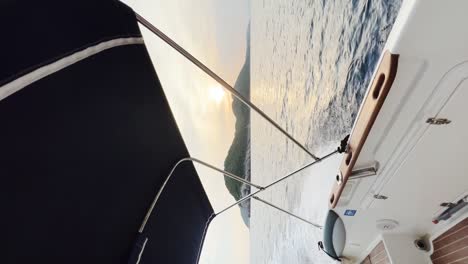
250, 0, 400, 264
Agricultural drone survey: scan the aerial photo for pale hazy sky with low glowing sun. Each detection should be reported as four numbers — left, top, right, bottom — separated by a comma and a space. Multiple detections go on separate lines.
123, 0, 250, 264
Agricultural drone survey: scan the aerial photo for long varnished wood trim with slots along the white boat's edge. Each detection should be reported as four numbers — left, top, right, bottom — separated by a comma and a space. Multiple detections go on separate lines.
329, 51, 399, 208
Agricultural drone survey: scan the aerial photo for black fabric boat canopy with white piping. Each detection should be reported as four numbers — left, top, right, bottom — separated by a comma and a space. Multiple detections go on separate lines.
0, 0, 213, 263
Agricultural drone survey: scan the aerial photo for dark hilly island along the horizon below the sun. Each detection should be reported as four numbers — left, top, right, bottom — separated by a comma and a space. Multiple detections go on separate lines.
224, 24, 250, 227
